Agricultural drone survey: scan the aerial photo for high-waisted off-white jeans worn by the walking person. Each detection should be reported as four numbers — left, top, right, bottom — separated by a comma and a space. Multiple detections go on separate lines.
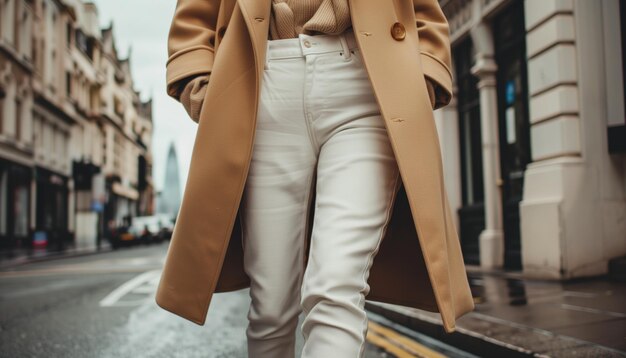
240, 31, 400, 358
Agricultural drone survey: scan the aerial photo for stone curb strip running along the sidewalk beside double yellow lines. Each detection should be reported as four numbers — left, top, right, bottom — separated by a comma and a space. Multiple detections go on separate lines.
365, 301, 625, 358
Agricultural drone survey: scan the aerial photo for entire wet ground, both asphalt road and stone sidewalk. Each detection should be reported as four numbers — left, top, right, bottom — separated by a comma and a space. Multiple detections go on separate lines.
0, 243, 626, 358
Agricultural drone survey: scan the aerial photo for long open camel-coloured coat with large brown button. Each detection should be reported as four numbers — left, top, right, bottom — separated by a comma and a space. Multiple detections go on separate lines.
156, 0, 474, 333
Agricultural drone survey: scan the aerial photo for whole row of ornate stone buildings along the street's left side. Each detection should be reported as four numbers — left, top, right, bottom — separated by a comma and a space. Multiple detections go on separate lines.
0, 0, 154, 256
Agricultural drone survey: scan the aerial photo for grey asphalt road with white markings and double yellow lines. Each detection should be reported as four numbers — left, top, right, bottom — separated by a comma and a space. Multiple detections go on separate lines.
0, 243, 468, 358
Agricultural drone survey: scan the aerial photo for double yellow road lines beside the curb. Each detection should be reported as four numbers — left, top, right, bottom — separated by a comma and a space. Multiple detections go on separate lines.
367, 320, 446, 358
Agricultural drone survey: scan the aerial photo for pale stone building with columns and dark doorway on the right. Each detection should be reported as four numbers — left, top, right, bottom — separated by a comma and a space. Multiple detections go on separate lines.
435, 0, 626, 279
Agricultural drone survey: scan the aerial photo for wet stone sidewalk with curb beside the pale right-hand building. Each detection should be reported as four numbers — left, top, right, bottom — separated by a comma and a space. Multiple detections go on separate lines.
367, 266, 626, 357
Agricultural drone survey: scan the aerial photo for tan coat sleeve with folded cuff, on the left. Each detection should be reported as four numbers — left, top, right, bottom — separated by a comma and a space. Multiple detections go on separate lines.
165, 0, 220, 101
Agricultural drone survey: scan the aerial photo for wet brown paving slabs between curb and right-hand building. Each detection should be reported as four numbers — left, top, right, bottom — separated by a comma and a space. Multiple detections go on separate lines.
468, 268, 626, 352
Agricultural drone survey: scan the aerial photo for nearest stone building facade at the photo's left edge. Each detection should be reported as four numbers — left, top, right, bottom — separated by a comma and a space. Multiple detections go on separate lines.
0, 0, 35, 255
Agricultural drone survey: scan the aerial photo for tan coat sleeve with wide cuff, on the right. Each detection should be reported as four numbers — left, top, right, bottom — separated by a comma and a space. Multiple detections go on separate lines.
413, 0, 452, 109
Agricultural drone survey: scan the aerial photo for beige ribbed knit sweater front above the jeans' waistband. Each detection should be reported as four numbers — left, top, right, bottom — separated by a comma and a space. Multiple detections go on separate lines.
268, 0, 351, 40
